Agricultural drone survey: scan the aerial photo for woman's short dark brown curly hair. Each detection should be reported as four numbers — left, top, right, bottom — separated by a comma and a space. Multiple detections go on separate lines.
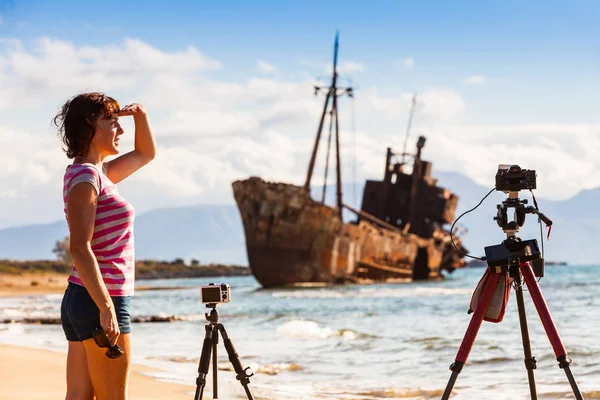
52, 92, 121, 158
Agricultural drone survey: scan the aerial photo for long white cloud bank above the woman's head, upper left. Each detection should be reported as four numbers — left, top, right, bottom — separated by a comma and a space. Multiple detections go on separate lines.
0, 37, 220, 109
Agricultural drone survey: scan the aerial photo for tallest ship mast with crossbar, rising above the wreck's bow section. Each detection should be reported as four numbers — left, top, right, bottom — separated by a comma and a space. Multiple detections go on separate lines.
304, 32, 353, 218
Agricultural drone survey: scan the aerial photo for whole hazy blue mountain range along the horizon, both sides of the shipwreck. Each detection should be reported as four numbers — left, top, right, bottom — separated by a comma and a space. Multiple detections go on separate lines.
0, 172, 600, 265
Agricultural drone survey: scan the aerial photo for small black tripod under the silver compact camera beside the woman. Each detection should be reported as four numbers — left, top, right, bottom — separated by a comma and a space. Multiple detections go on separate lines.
194, 303, 254, 400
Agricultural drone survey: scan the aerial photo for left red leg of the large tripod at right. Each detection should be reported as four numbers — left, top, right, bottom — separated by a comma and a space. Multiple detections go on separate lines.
442, 273, 503, 400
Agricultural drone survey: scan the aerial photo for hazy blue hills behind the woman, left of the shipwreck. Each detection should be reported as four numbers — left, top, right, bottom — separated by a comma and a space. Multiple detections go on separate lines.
0, 204, 247, 265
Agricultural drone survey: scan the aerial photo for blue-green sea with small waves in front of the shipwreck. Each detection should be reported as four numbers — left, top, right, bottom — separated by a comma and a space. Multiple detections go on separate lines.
0, 265, 600, 400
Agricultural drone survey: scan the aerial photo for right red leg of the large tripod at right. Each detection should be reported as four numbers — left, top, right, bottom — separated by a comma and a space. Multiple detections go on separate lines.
519, 262, 583, 400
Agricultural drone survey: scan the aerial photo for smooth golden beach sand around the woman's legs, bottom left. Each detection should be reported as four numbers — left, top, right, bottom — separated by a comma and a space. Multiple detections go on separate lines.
0, 344, 197, 400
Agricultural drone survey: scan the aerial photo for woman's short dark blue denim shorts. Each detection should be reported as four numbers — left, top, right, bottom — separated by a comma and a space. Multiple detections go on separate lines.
60, 282, 131, 342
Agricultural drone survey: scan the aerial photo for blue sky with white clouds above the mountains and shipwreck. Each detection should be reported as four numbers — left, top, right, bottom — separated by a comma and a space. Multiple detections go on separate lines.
0, 0, 600, 227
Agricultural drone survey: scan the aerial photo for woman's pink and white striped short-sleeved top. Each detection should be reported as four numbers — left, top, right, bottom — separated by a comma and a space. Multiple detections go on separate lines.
63, 163, 135, 296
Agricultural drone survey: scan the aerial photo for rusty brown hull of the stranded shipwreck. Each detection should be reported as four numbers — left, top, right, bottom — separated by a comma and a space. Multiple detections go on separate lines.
232, 177, 462, 287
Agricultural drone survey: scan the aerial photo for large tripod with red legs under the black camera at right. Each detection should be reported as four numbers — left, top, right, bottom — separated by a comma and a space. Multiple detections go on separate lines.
442, 193, 583, 400
